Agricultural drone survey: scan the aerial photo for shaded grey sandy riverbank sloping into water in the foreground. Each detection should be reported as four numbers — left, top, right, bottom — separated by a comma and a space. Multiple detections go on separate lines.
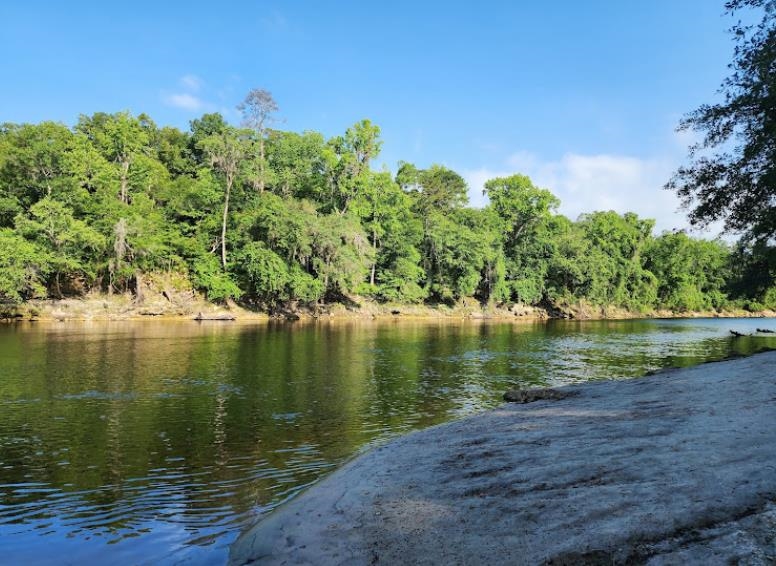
230, 352, 776, 564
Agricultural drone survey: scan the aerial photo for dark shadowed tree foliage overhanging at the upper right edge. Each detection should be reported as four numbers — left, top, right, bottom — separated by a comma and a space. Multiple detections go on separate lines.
666, 0, 776, 241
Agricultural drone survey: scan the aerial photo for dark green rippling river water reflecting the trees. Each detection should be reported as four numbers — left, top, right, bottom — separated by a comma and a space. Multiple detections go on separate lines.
0, 319, 776, 566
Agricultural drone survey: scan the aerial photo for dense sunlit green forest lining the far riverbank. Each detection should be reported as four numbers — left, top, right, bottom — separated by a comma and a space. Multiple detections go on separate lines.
0, 90, 776, 312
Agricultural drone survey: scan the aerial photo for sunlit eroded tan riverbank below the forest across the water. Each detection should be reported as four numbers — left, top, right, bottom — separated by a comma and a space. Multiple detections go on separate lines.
0, 290, 776, 321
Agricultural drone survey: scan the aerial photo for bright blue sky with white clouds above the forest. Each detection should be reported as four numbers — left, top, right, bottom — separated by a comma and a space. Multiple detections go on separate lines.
0, 0, 733, 233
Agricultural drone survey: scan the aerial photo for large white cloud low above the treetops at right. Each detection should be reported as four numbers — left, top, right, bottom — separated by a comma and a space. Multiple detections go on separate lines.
464, 149, 719, 237
